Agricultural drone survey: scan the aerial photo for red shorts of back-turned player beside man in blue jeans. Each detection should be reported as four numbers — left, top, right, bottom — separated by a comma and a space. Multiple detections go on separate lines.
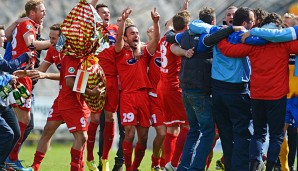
157, 84, 188, 126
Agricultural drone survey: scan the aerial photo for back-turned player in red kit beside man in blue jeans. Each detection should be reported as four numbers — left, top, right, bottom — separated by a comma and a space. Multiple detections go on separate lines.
157, 11, 190, 170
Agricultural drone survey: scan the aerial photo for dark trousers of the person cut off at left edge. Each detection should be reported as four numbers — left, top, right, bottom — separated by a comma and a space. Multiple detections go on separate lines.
0, 106, 21, 167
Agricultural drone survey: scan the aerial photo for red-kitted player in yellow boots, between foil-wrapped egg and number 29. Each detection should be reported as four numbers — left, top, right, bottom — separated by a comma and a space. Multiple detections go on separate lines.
87, 4, 119, 171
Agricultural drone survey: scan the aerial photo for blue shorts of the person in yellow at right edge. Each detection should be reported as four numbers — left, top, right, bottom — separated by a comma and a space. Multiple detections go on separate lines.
286, 97, 298, 127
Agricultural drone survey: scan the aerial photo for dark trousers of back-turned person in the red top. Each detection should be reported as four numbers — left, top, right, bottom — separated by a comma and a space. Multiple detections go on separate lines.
249, 97, 287, 163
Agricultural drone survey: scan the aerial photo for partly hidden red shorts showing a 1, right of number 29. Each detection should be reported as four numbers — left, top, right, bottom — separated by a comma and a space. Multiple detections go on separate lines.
149, 93, 165, 127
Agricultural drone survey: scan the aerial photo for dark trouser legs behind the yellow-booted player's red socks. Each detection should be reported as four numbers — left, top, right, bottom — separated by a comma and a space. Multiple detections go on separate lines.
97, 108, 125, 165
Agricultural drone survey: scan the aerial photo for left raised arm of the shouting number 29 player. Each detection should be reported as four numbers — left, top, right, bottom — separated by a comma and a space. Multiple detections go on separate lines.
115, 8, 132, 53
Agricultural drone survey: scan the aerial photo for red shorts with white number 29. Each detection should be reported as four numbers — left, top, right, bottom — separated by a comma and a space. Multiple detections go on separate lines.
120, 90, 150, 127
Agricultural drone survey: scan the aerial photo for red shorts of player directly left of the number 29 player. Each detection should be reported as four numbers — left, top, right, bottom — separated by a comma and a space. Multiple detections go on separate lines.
104, 76, 119, 112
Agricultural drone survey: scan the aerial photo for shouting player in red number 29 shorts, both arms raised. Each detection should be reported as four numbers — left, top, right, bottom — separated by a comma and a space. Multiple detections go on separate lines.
115, 8, 159, 171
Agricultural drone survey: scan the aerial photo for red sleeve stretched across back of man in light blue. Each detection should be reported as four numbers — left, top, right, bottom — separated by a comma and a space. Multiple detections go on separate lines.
218, 39, 252, 58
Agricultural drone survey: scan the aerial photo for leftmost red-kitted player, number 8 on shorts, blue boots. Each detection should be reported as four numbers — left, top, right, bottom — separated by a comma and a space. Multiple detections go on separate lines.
7, 0, 50, 169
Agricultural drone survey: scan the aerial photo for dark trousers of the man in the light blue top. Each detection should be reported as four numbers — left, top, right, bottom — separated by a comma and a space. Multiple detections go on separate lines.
212, 81, 251, 171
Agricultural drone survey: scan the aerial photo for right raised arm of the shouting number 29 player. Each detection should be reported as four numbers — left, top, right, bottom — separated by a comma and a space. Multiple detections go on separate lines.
147, 8, 160, 54
